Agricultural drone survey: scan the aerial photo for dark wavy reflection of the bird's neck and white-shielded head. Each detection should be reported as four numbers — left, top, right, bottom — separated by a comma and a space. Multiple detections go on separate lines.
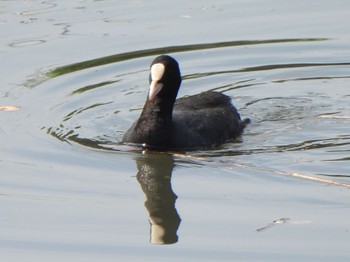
136, 153, 181, 244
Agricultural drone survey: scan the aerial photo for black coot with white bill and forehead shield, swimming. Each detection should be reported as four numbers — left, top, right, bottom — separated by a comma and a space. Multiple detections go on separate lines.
122, 55, 250, 151
